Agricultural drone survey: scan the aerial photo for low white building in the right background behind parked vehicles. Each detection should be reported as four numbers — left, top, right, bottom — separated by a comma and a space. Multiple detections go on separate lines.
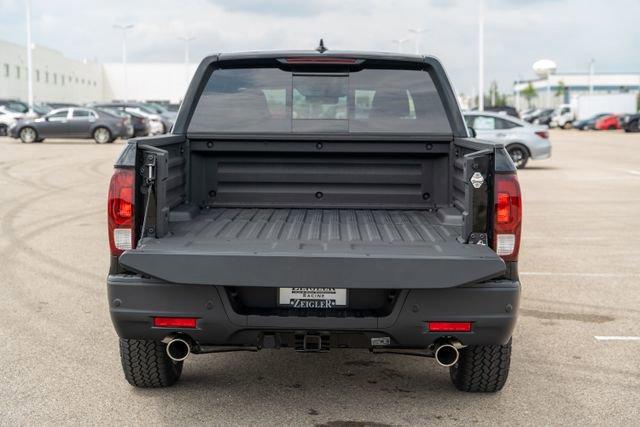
513, 73, 640, 109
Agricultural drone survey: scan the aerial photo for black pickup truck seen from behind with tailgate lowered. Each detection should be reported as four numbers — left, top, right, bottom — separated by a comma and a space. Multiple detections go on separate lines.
108, 51, 521, 392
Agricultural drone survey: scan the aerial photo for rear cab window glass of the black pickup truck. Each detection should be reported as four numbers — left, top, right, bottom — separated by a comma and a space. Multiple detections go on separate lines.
188, 67, 452, 134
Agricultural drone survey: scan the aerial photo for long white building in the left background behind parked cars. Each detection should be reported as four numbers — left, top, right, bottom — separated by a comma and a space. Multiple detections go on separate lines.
0, 40, 197, 104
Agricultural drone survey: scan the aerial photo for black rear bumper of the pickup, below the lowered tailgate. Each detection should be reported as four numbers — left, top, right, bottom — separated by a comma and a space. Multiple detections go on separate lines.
108, 275, 520, 349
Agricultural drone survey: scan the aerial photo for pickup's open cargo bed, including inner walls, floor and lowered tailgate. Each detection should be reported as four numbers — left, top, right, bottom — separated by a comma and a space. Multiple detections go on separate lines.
120, 141, 504, 289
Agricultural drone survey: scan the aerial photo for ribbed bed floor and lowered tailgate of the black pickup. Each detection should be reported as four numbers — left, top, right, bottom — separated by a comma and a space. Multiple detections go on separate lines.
120, 208, 505, 288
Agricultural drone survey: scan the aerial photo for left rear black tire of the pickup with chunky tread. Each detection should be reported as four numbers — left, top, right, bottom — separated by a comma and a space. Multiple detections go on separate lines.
120, 338, 182, 388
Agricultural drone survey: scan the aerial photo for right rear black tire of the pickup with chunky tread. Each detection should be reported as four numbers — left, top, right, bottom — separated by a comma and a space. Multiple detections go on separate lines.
449, 340, 511, 393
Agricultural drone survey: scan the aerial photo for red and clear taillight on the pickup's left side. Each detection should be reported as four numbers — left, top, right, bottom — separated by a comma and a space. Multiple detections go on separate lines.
107, 169, 135, 255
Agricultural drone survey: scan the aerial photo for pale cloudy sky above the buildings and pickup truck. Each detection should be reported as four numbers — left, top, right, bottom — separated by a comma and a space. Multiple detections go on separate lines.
0, 0, 640, 95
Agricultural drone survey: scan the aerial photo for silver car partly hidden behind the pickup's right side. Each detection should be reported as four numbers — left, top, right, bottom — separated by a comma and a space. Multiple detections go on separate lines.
464, 111, 551, 169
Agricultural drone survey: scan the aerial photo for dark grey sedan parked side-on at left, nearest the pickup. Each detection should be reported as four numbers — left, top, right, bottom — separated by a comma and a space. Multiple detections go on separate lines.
9, 108, 133, 144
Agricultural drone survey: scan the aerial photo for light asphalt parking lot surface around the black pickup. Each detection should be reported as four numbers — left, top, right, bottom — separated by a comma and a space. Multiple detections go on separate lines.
0, 131, 640, 426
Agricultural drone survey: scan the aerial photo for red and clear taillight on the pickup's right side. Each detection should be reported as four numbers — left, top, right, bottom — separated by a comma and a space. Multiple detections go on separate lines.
493, 173, 522, 261
